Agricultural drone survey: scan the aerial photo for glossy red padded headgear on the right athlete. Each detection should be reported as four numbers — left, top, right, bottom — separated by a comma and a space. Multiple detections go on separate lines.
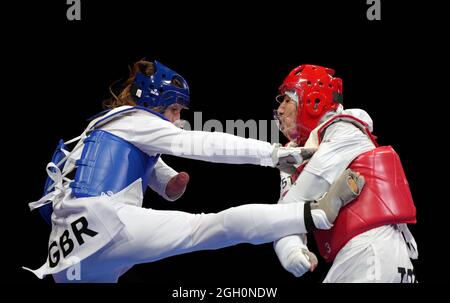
279, 64, 342, 146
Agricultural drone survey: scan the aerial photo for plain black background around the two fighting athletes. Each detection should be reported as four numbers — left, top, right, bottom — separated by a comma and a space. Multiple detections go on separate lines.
4, 0, 446, 296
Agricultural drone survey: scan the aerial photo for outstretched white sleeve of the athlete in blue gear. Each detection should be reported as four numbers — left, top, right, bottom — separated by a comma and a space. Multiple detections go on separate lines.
102, 111, 274, 167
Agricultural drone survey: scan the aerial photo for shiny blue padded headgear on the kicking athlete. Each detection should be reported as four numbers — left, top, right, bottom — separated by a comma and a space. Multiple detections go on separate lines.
131, 60, 189, 108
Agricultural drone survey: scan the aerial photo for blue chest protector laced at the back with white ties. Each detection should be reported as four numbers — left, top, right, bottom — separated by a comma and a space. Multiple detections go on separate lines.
39, 107, 167, 224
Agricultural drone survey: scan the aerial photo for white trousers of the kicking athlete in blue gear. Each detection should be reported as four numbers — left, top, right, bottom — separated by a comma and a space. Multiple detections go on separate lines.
53, 203, 306, 282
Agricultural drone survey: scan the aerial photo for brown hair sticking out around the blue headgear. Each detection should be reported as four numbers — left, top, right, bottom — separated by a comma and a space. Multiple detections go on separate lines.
103, 59, 183, 112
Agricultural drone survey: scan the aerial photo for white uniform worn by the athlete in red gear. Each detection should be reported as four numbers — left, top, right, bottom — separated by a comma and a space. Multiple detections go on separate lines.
274, 109, 418, 282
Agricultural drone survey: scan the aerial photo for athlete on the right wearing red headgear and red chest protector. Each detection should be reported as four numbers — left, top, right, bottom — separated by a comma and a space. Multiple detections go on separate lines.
274, 65, 418, 282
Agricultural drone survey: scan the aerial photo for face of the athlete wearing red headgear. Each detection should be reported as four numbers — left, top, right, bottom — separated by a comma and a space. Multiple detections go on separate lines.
276, 95, 298, 141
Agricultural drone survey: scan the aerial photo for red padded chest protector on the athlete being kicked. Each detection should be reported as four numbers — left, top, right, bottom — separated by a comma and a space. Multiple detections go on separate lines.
296, 115, 416, 262
